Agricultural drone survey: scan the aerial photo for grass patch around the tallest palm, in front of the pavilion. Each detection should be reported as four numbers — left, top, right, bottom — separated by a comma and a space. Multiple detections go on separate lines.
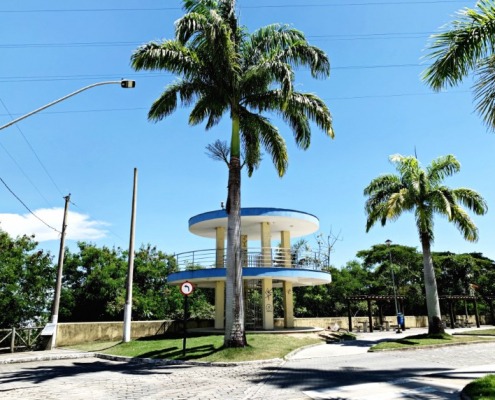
63, 334, 323, 362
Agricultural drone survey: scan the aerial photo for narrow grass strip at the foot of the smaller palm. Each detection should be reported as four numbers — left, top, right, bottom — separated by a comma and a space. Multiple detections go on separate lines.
369, 333, 490, 352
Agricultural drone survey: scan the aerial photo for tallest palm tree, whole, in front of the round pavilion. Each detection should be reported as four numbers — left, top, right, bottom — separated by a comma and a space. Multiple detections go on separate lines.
131, 0, 333, 347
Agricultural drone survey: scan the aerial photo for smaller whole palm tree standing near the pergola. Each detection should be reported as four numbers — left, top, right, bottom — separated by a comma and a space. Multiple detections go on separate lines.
364, 154, 488, 334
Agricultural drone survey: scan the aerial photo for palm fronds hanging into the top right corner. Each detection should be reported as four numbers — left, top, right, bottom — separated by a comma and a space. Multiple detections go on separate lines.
422, 0, 495, 129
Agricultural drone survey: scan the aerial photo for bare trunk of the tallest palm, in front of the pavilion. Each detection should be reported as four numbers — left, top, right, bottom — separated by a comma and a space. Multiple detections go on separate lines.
224, 118, 247, 347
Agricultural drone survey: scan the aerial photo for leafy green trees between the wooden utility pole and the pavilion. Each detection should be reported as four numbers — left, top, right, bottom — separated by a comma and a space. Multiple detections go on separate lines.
60, 242, 214, 321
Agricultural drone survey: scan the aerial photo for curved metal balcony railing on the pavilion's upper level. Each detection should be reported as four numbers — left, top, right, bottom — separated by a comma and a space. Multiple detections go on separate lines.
175, 247, 328, 271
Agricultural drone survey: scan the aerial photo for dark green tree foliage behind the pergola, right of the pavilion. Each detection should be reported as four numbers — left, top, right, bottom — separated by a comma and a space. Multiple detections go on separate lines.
294, 244, 495, 317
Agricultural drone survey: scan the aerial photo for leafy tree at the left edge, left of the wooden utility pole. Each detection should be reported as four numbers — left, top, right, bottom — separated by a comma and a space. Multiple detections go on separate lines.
0, 230, 55, 328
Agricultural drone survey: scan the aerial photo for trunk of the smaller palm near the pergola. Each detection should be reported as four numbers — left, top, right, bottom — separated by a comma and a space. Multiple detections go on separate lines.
421, 235, 445, 335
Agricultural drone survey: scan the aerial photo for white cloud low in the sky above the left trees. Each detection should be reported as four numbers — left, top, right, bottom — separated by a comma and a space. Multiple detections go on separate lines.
0, 208, 109, 242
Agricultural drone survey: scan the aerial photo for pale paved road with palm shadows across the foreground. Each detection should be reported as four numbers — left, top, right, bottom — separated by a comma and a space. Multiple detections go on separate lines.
0, 332, 495, 400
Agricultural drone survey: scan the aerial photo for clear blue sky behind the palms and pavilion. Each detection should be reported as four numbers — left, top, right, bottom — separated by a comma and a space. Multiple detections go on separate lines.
0, 0, 495, 266
